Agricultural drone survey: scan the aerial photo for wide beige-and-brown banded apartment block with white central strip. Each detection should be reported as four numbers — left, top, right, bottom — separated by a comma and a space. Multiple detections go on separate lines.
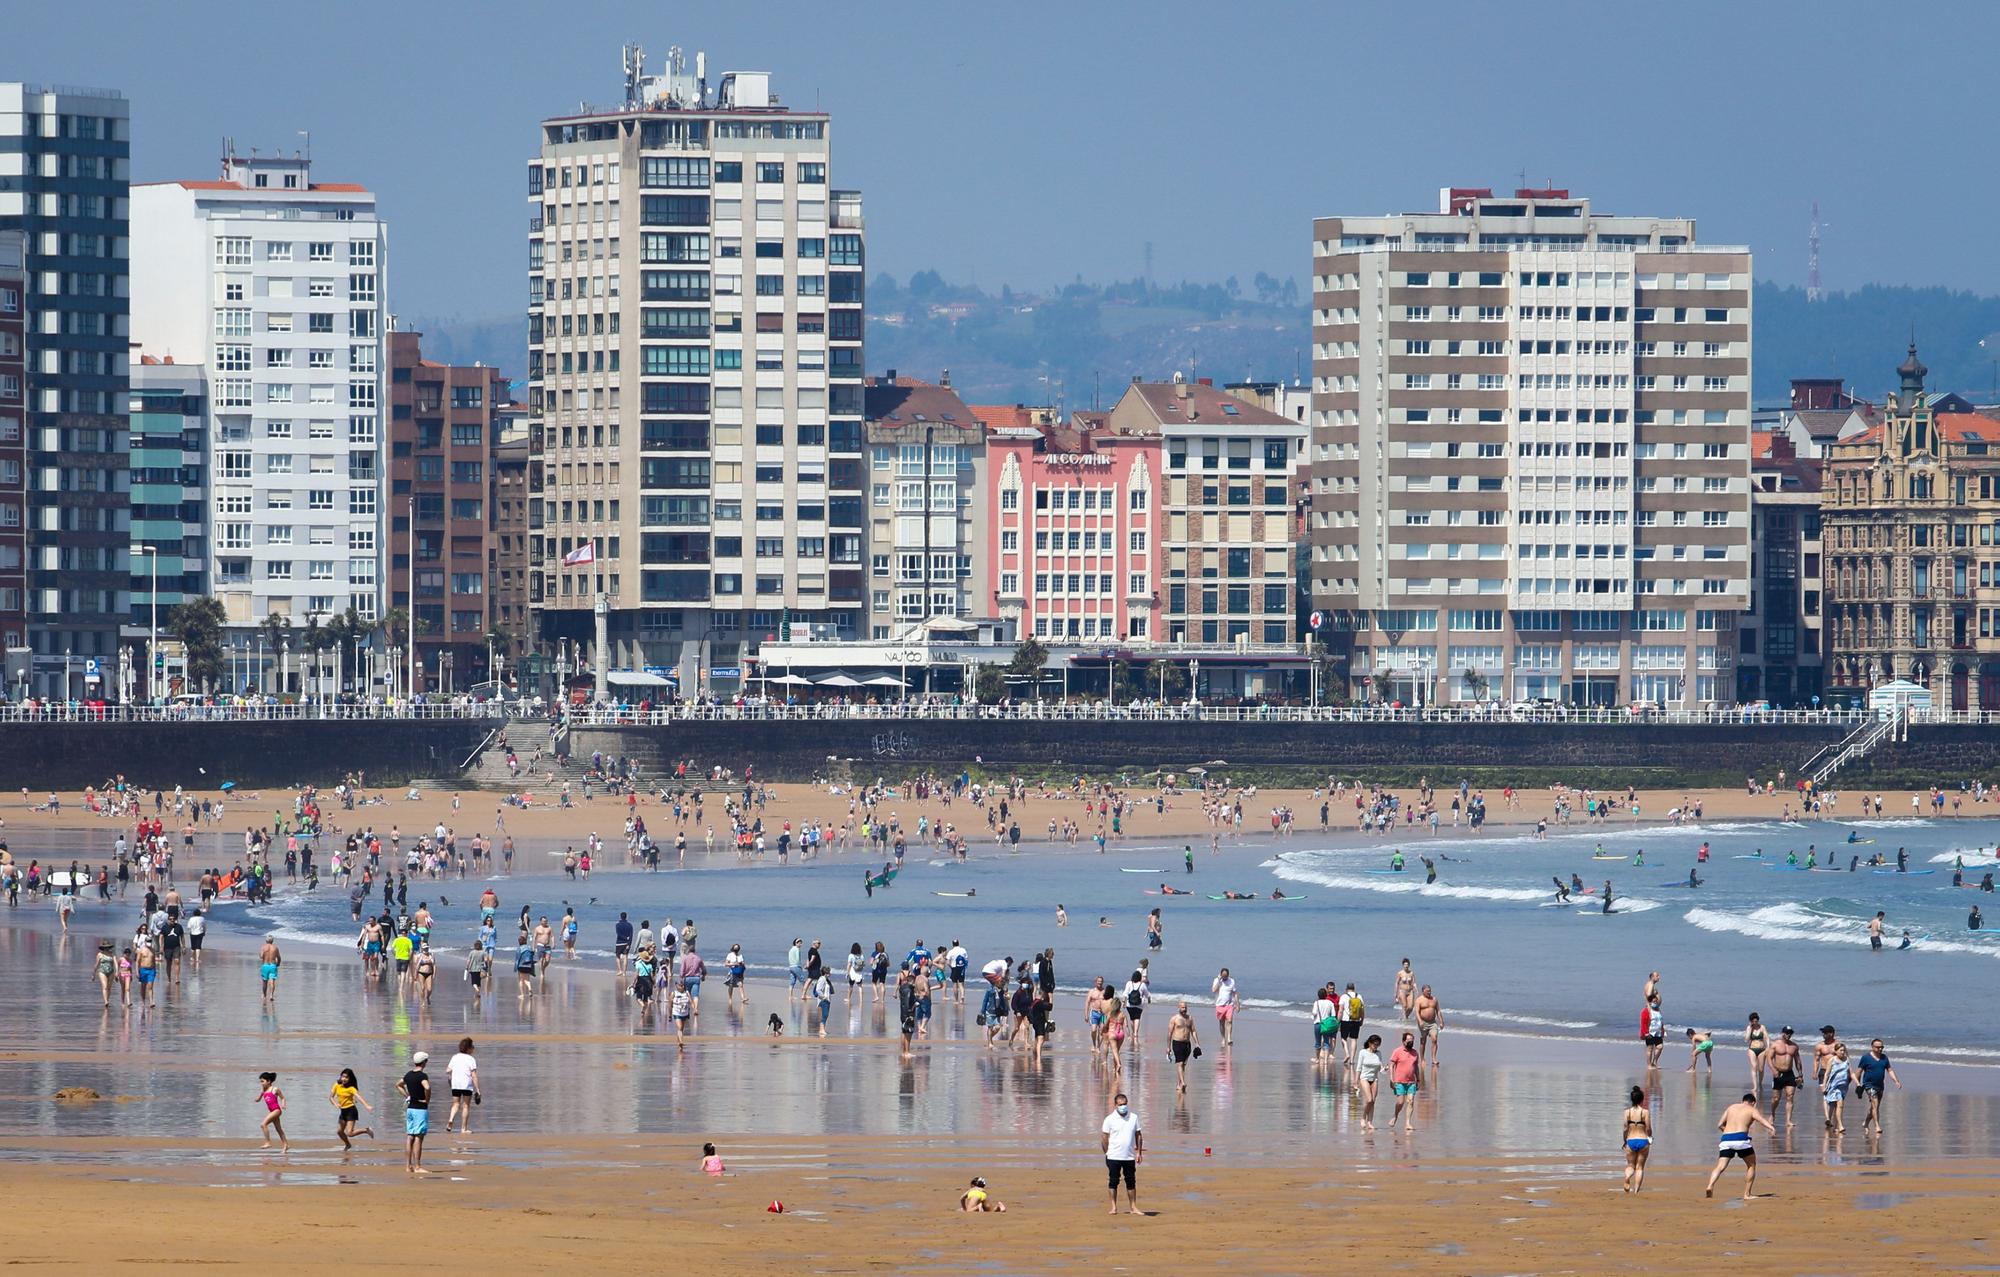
1310, 188, 1750, 707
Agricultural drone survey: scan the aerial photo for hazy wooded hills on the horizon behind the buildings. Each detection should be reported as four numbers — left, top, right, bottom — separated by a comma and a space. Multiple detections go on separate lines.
408, 270, 2000, 408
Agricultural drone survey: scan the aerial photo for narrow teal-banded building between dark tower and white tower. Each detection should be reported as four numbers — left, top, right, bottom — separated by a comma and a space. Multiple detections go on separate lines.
124, 354, 210, 697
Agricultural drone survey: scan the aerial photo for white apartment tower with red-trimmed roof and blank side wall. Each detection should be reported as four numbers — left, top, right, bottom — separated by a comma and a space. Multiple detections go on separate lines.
132, 148, 388, 628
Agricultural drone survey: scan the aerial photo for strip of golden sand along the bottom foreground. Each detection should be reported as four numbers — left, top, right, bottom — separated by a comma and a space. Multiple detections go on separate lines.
0, 1137, 1996, 1273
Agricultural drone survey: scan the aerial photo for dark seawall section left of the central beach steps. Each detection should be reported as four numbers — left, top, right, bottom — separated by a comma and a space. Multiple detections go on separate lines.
0, 719, 494, 791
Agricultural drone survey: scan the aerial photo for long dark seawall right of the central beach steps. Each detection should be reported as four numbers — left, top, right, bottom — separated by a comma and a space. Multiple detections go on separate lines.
570, 719, 1872, 785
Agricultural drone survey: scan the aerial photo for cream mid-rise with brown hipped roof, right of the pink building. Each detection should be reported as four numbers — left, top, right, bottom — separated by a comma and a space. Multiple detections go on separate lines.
1108, 372, 1306, 660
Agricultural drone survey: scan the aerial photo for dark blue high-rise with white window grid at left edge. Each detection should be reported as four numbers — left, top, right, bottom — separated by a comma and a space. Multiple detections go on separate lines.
0, 84, 132, 697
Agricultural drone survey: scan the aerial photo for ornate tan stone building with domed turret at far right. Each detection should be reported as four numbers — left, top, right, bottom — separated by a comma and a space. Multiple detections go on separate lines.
1822, 344, 2000, 711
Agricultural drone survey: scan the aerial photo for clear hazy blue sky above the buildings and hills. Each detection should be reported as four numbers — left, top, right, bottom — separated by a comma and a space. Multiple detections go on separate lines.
15, 0, 2000, 318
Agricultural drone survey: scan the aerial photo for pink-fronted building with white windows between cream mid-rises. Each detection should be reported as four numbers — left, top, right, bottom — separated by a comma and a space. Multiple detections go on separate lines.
986, 426, 1162, 643
